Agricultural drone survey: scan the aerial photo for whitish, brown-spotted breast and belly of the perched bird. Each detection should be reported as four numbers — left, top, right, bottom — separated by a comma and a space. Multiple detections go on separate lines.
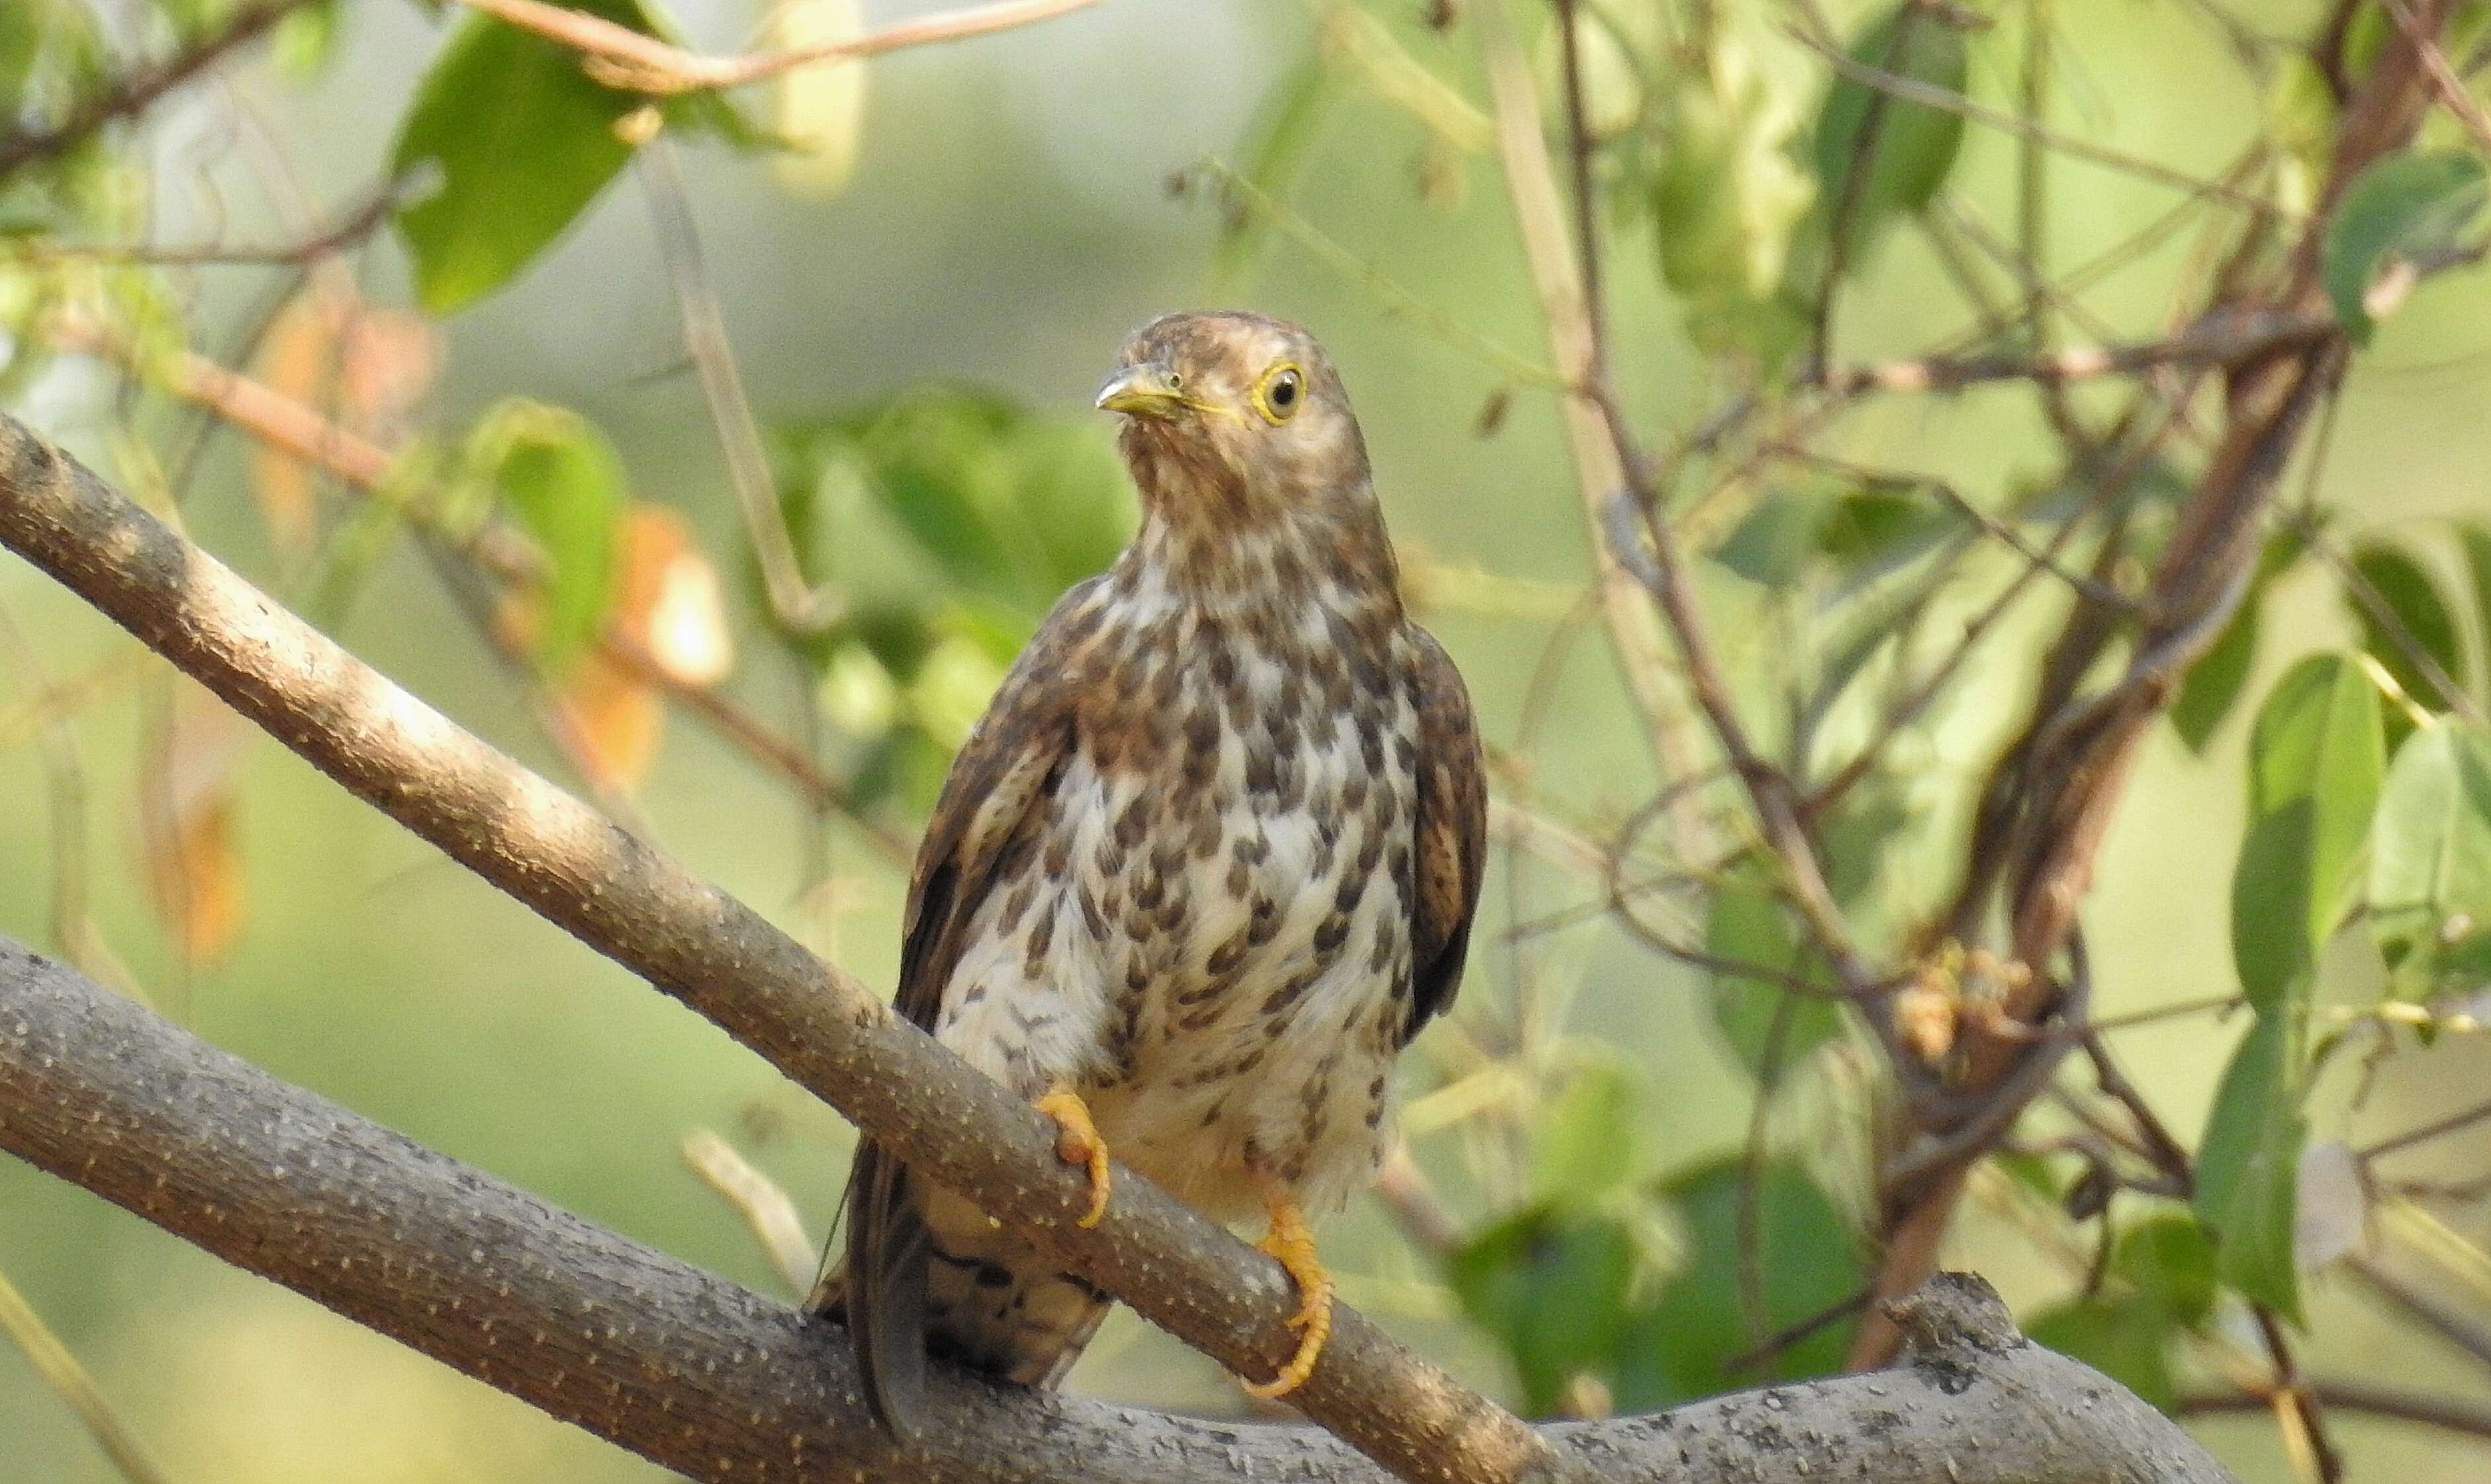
937, 573, 1417, 1220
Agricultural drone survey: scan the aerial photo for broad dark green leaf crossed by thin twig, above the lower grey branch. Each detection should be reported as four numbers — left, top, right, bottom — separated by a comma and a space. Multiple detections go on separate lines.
1612, 1158, 1865, 1412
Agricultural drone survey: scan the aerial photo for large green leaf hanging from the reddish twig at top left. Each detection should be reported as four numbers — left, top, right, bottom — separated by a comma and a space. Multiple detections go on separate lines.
394, 0, 645, 314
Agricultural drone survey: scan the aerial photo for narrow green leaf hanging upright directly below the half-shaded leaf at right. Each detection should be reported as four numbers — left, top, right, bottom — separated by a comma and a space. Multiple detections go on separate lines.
2197, 1013, 2309, 1320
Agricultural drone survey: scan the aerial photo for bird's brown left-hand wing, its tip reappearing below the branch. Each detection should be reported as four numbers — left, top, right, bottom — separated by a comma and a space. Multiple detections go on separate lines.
815, 578, 1096, 1437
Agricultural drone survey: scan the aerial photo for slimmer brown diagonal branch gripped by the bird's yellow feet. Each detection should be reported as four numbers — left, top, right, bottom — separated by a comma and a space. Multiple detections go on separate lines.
0, 416, 1572, 1484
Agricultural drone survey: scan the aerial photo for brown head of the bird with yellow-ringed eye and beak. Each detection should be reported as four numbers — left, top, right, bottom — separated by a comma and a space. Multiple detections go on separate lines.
1098, 314, 1375, 526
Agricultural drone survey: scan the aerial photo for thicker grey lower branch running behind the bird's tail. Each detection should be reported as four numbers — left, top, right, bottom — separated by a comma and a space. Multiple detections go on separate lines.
0, 939, 2232, 1484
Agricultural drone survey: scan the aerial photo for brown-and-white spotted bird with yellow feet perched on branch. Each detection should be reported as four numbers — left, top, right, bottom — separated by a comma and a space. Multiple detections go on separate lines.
815, 314, 1487, 1434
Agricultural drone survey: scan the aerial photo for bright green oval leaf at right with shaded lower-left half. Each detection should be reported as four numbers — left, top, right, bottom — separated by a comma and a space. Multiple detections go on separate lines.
2232, 655, 2386, 1011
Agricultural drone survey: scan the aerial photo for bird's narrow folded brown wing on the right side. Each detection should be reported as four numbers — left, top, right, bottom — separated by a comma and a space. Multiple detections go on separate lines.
1403, 622, 1487, 1046
